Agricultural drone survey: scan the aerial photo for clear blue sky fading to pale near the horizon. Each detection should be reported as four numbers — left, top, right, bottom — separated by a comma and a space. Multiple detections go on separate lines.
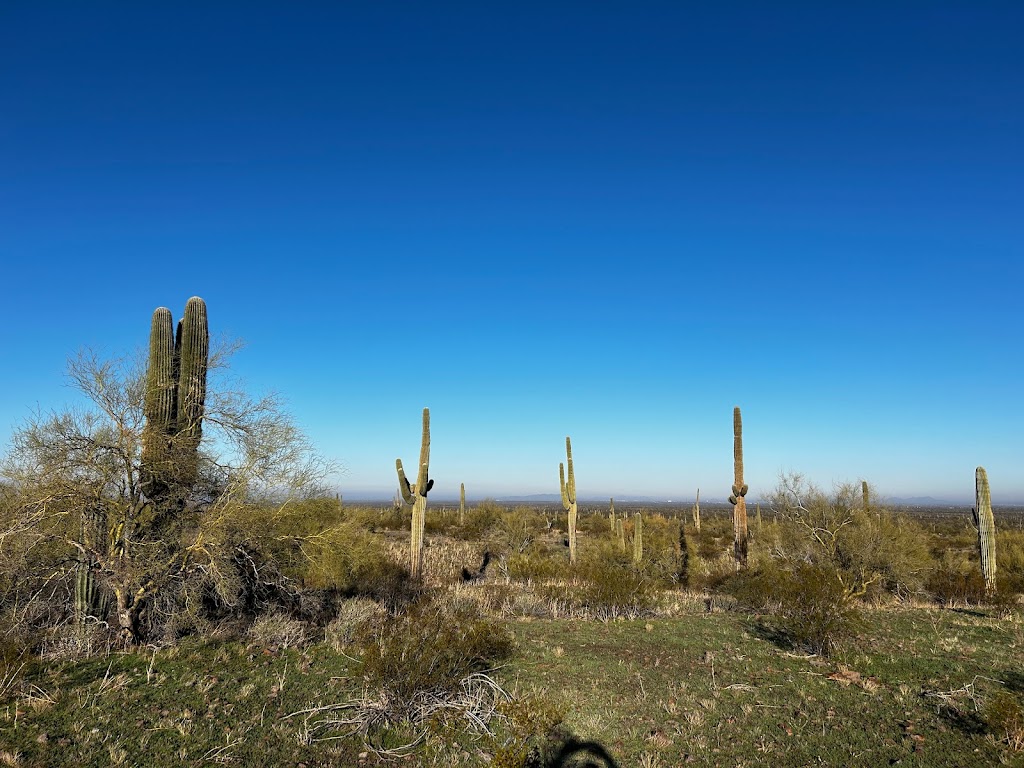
0, 2, 1024, 503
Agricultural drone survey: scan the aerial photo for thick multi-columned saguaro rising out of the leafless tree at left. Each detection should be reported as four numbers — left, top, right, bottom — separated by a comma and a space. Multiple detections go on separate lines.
141, 296, 210, 501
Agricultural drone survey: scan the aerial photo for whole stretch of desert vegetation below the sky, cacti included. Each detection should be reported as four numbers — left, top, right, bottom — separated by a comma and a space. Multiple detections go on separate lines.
0, 298, 1024, 768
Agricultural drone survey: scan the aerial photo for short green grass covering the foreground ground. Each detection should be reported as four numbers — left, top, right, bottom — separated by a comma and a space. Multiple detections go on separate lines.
0, 603, 1024, 768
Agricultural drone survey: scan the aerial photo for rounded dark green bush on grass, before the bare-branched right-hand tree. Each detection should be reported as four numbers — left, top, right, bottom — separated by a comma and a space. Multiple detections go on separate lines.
728, 562, 857, 653
